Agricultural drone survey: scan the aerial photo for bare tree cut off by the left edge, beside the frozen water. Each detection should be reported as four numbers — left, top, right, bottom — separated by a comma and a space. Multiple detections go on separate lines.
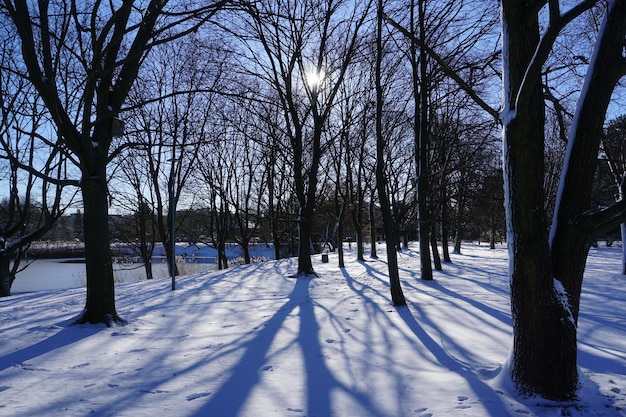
0, 56, 74, 297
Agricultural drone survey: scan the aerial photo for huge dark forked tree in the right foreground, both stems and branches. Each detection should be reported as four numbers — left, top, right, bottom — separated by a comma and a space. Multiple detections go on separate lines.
386, 0, 626, 400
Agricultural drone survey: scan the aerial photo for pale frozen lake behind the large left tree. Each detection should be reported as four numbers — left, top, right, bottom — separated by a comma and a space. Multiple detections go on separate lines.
11, 259, 216, 294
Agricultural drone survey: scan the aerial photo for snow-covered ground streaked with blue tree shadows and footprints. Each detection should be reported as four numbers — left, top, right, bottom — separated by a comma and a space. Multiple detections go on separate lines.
0, 245, 626, 417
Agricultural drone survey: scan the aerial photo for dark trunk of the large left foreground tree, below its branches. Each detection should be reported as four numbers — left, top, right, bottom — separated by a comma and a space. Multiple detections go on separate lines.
77, 176, 124, 326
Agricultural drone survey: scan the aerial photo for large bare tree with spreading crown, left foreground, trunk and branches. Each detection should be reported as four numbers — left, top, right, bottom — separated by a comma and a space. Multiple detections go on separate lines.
0, 0, 229, 325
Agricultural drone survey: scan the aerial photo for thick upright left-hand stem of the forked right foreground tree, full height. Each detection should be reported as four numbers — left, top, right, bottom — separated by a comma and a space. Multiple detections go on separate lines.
502, 0, 577, 400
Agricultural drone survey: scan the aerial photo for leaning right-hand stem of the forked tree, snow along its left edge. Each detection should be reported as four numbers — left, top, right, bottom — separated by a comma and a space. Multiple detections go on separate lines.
551, 1, 626, 322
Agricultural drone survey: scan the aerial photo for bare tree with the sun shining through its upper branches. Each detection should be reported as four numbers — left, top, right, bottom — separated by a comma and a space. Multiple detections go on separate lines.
232, 0, 370, 275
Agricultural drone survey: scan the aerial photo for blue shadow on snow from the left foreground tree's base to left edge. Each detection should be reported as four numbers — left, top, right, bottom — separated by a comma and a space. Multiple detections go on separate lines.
0, 322, 101, 372
